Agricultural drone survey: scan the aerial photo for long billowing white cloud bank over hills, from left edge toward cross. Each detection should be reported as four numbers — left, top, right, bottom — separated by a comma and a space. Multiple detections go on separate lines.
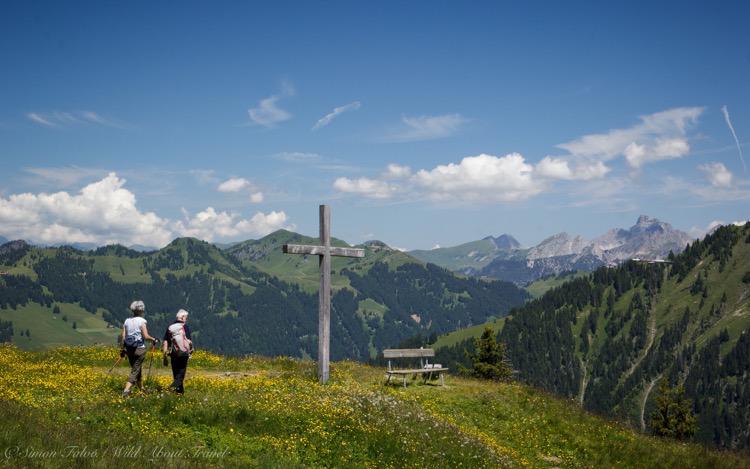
0, 173, 287, 246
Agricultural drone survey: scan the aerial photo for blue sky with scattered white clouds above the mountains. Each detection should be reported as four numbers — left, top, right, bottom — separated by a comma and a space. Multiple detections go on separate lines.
0, 2, 750, 249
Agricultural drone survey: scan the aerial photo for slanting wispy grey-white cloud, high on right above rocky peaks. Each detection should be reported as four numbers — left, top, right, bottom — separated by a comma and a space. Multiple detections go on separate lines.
557, 107, 704, 168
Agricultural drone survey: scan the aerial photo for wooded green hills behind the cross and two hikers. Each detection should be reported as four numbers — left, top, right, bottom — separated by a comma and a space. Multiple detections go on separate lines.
0, 231, 526, 360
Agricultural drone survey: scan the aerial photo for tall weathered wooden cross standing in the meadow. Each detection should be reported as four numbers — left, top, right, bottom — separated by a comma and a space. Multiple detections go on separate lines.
282, 205, 365, 384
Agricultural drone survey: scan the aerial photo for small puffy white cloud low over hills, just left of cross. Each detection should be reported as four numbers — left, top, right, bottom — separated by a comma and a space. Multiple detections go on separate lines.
174, 207, 293, 242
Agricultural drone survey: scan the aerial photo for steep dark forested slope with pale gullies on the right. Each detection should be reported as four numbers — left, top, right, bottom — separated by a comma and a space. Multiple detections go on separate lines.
439, 224, 750, 448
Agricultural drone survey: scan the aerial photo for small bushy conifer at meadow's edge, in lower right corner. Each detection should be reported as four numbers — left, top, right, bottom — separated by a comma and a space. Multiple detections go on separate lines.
651, 382, 698, 440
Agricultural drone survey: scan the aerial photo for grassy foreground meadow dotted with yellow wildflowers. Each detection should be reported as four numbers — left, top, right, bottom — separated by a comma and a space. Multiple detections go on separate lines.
0, 346, 750, 468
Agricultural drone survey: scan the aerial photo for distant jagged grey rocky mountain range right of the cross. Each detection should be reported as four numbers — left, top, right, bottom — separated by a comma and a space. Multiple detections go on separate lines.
409, 215, 692, 285
